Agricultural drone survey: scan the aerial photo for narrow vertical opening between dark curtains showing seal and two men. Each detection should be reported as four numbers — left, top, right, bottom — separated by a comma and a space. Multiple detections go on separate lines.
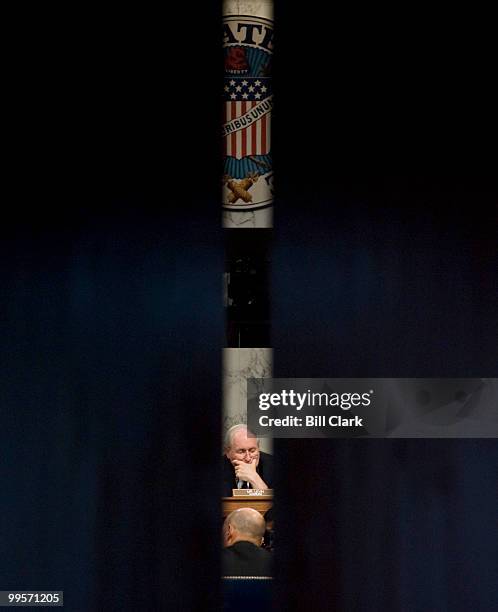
221, 0, 274, 612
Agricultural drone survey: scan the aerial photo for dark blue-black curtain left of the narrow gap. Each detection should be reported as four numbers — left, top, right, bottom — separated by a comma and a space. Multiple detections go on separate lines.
0, 6, 223, 610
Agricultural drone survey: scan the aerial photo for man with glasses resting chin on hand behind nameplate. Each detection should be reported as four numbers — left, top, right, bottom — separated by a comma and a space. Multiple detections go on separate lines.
223, 423, 273, 497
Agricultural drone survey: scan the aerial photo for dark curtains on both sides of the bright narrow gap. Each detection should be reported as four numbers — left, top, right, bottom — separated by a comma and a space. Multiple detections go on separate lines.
0, 2, 498, 610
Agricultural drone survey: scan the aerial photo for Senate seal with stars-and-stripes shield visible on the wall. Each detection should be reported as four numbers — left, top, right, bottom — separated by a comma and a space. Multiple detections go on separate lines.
222, 15, 273, 211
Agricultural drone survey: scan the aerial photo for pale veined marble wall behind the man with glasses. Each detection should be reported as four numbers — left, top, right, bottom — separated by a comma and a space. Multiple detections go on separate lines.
222, 348, 272, 453
